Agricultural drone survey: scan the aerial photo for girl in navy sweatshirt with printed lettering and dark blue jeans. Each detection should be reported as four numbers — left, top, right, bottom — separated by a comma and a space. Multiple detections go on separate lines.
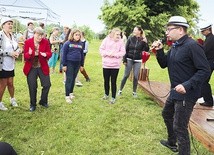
62, 30, 84, 103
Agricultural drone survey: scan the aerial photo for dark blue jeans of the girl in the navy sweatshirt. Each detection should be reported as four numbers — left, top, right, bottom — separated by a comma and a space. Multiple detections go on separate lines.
65, 61, 80, 96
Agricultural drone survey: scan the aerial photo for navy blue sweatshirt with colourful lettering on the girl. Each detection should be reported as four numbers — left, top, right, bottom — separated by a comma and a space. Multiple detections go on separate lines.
62, 40, 84, 66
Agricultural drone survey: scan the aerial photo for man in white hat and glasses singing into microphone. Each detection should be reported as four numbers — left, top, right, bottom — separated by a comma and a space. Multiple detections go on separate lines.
152, 16, 210, 155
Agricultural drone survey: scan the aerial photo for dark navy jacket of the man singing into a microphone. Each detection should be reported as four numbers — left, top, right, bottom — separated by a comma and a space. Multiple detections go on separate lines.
157, 35, 210, 102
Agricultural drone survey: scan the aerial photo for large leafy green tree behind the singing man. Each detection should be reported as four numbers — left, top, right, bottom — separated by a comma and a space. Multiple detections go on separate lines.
98, 0, 199, 41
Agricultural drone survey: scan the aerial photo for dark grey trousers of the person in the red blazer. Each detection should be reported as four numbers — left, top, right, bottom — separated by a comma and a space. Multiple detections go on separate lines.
27, 67, 51, 106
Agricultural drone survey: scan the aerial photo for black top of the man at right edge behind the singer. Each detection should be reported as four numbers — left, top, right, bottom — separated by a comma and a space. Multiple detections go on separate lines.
203, 33, 214, 60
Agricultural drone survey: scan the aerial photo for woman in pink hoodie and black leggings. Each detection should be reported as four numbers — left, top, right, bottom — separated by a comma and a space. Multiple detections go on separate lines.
100, 28, 126, 104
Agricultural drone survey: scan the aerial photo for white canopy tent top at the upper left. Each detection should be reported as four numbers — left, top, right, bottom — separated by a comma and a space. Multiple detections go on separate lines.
0, 0, 60, 23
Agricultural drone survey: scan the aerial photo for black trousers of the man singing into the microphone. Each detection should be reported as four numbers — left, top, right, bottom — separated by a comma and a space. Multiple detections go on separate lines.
162, 98, 195, 155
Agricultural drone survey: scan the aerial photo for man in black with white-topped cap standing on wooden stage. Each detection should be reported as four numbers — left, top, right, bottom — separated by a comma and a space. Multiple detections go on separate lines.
200, 23, 214, 107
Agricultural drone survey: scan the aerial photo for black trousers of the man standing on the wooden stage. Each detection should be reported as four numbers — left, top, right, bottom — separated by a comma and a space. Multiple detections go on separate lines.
201, 60, 214, 105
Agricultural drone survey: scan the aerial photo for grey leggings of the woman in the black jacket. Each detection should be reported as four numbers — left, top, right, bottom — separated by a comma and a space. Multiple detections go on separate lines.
120, 60, 141, 92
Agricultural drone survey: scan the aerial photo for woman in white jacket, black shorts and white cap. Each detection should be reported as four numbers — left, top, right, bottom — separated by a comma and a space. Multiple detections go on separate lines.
0, 18, 19, 110
